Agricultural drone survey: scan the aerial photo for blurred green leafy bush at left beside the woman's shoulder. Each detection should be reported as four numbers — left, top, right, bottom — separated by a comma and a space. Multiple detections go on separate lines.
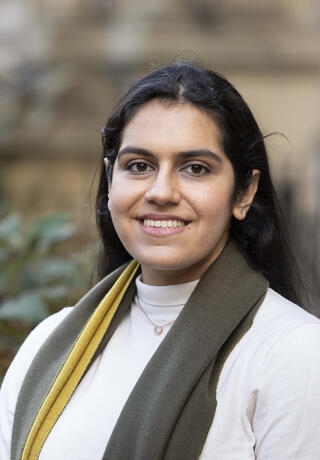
0, 213, 92, 376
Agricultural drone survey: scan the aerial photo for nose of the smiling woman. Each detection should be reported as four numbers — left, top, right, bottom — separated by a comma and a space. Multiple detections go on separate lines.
145, 171, 180, 206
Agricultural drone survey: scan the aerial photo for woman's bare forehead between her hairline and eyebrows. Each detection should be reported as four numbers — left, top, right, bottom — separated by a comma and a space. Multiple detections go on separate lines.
121, 99, 222, 151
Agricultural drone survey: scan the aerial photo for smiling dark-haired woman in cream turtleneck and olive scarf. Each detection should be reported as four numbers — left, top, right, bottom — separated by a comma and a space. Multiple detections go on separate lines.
0, 62, 320, 460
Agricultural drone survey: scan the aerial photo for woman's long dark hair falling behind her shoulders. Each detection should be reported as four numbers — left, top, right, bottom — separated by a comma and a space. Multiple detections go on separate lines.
96, 61, 302, 303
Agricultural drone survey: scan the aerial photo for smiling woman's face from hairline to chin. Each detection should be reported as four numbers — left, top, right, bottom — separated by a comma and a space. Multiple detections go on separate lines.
109, 100, 242, 285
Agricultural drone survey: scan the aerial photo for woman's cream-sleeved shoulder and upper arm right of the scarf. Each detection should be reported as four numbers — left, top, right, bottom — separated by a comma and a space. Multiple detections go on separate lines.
212, 289, 320, 459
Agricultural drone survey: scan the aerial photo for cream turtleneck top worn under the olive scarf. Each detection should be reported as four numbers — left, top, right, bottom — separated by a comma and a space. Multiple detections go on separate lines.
0, 278, 320, 460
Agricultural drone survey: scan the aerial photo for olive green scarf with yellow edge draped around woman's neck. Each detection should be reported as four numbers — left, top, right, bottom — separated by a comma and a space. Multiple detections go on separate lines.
11, 241, 268, 460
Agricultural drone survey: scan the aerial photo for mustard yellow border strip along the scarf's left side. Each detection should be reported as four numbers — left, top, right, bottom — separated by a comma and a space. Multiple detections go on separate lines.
21, 260, 139, 460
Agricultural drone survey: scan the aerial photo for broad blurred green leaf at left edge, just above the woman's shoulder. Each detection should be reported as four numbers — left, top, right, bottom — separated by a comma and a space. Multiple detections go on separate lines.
0, 293, 50, 323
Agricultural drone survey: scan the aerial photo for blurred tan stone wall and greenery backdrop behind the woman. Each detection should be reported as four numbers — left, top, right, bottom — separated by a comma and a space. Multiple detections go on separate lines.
0, 0, 320, 380
